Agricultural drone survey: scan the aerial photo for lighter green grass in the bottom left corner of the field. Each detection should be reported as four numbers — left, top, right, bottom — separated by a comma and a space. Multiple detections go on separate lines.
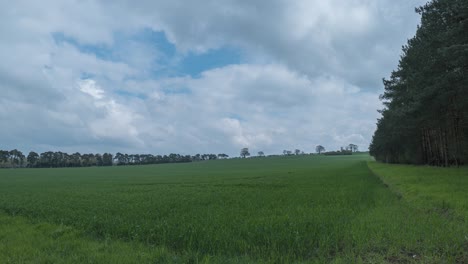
0, 215, 182, 263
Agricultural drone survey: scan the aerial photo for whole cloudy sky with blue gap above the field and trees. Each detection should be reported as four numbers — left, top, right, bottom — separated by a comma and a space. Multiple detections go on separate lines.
0, 0, 425, 156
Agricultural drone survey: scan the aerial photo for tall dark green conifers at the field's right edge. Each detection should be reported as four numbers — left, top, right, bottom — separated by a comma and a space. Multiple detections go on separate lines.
369, 0, 468, 166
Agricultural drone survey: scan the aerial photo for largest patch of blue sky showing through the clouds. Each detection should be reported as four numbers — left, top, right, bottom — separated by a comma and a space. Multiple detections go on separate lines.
52, 28, 244, 79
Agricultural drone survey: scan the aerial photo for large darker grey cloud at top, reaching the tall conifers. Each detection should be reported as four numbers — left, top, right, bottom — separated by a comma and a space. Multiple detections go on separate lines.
107, 0, 425, 90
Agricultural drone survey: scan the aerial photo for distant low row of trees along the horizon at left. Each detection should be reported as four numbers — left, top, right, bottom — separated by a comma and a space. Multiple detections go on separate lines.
0, 149, 229, 168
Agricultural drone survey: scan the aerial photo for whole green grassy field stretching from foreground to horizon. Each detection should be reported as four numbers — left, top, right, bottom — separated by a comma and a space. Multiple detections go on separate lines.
0, 155, 468, 263
